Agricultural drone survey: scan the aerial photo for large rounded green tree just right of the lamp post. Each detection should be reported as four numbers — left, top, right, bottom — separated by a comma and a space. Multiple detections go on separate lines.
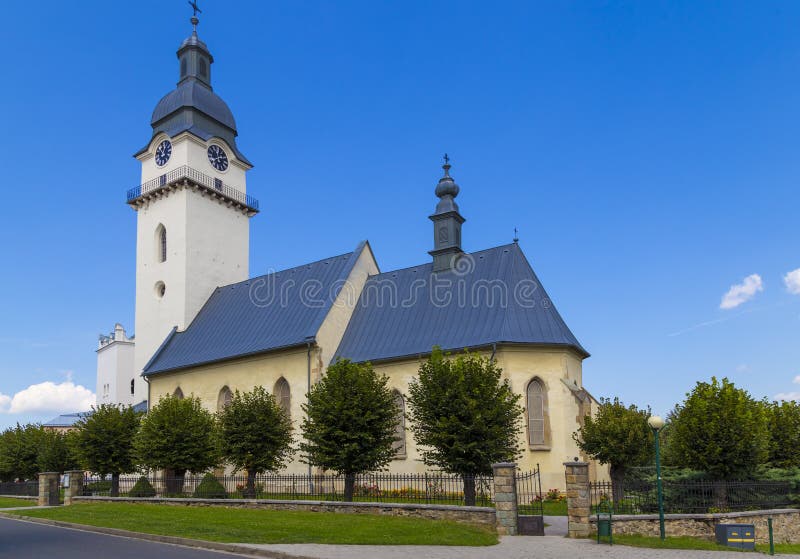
669, 377, 769, 480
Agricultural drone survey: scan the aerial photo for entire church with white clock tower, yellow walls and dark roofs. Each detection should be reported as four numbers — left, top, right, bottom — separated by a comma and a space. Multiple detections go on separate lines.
89, 10, 600, 488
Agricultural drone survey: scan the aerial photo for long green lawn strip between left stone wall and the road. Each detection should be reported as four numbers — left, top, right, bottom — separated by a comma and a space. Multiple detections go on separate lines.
19, 503, 497, 546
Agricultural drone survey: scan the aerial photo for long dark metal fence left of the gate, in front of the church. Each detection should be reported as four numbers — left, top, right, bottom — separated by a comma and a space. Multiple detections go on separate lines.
84, 473, 493, 506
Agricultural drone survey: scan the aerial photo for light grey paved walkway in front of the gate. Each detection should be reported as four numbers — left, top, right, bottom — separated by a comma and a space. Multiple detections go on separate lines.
248, 536, 800, 559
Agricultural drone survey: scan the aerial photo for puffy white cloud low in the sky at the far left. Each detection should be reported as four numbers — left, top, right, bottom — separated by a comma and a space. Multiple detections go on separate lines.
0, 380, 95, 414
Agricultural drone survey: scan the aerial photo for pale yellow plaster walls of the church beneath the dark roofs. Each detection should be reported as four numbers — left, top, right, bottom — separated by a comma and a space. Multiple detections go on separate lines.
150, 342, 608, 490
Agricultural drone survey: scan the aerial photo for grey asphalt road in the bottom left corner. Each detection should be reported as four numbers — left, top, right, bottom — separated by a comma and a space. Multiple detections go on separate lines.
0, 518, 242, 559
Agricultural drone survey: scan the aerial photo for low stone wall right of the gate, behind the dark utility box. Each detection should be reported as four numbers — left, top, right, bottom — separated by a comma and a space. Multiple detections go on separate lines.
590, 509, 800, 544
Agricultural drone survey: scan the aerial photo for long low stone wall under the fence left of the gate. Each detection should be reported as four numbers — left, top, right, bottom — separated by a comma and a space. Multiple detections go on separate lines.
78, 497, 496, 528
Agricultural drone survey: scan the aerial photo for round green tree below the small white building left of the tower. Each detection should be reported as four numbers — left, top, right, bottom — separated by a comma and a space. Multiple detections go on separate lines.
74, 404, 141, 497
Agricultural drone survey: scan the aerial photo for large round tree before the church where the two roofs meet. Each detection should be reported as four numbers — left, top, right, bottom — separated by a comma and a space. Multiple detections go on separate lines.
300, 359, 397, 501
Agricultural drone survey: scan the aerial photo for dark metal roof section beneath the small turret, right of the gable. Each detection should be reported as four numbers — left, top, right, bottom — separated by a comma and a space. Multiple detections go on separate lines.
336, 243, 589, 361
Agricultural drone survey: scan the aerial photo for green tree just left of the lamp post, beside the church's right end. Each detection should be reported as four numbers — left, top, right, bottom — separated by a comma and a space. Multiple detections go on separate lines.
572, 398, 654, 501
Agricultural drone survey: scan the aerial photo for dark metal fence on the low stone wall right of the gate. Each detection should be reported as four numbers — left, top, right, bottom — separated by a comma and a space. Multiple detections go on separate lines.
590, 480, 800, 514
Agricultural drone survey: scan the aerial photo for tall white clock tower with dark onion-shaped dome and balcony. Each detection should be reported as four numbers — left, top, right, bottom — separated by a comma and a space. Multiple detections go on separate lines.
127, 14, 258, 401
